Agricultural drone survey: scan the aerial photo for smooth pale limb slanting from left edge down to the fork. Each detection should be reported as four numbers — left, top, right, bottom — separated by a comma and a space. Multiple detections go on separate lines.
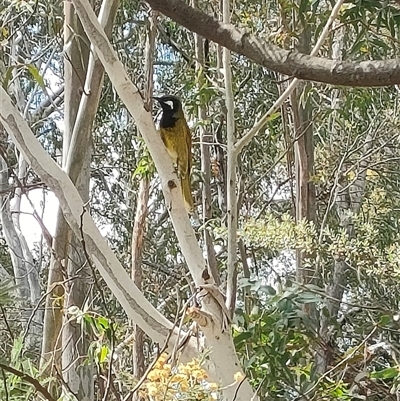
0, 88, 194, 352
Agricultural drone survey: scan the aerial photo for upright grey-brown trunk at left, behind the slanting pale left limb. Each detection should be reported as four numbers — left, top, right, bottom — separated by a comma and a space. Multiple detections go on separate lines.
56, 2, 94, 401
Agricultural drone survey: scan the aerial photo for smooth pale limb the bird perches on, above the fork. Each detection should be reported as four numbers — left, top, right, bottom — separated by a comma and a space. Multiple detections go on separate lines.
69, 0, 206, 285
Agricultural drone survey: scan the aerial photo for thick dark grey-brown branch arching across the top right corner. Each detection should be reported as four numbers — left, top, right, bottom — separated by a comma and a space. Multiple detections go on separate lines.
146, 0, 400, 87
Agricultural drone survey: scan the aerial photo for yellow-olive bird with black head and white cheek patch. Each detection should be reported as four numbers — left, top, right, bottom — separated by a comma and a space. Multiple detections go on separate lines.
153, 95, 193, 213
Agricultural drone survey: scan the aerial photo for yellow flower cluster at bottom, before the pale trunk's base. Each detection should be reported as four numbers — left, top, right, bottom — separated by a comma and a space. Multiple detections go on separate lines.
140, 353, 220, 401
